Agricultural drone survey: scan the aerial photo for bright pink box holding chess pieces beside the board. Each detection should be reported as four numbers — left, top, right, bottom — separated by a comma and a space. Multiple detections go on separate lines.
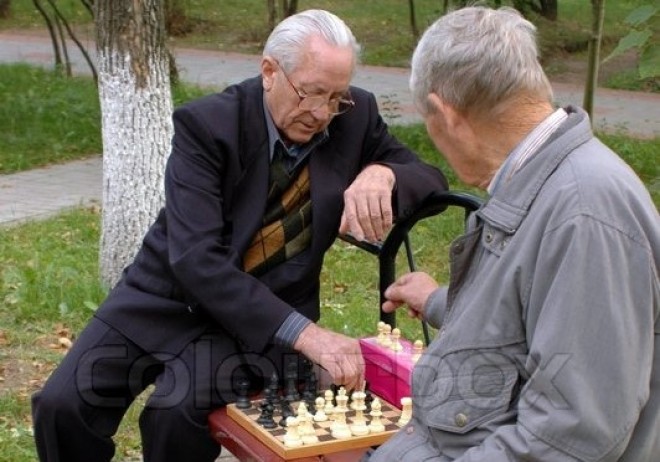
360, 337, 414, 409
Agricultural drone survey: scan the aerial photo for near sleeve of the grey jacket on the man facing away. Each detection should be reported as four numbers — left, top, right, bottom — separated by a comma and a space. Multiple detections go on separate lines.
457, 215, 659, 462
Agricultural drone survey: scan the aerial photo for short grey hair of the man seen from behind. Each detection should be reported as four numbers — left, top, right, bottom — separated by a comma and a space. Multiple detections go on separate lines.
410, 7, 552, 115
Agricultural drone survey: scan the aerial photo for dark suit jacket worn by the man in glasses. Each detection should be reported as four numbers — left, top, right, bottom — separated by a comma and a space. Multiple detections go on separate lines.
97, 77, 446, 353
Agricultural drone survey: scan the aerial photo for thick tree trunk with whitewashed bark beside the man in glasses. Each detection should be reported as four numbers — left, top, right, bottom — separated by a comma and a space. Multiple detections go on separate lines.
94, 0, 173, 286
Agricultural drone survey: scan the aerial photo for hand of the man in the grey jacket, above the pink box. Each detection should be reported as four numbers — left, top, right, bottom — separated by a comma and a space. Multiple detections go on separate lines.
383, 271, 439, 318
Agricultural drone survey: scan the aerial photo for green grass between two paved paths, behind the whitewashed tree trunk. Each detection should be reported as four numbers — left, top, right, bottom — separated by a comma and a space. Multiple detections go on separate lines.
0, 64, 204, 173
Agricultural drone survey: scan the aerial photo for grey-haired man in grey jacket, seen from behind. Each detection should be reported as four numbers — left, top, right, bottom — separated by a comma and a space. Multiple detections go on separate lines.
370, 7, 660, 462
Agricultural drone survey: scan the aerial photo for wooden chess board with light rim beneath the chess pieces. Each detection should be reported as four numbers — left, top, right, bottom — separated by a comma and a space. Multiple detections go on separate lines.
227, 399, 401, 460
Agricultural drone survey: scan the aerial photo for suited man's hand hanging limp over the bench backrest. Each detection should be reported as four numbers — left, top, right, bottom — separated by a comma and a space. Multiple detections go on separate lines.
339, 164, 396, 242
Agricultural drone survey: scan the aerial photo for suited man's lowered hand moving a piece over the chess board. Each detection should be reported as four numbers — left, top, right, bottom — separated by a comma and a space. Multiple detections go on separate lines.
293, 323, 364, 390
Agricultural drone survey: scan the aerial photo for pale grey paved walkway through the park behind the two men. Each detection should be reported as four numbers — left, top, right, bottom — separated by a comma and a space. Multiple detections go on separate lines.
0, 29, 660, 229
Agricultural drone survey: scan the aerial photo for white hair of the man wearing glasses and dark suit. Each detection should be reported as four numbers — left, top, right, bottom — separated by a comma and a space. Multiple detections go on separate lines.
263, 10, 360, 72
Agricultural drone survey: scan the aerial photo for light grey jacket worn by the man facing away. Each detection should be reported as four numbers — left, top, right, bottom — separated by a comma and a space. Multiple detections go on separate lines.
370, 108, 660, 462
